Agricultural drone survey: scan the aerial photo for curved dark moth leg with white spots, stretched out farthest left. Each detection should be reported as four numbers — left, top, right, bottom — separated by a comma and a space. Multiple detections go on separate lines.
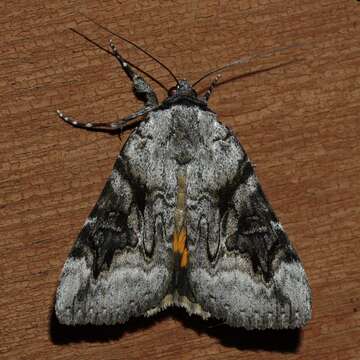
57, 106, 152, 131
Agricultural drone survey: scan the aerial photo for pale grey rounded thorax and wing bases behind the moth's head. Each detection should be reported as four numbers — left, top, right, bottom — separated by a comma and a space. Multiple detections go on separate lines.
122, 105, 245, 201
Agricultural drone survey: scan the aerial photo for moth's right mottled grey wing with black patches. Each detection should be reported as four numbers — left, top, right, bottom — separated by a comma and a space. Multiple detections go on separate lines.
187, 129, 311, 329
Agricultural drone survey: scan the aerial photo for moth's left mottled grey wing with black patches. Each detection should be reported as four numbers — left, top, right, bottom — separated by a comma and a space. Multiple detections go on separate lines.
55, 154, 173, 324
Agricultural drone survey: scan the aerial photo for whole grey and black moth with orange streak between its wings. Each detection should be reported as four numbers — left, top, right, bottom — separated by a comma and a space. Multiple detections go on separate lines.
55, 25, 311, 329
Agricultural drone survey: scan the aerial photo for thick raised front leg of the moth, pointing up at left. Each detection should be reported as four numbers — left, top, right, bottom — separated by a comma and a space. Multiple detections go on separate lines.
110, 40, 159, 107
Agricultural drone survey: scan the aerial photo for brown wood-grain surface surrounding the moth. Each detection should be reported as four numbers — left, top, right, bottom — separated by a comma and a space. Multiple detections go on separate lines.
0, 0, 360, 360
